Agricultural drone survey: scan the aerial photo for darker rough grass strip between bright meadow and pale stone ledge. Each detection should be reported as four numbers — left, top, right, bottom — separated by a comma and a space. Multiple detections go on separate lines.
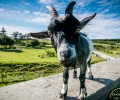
0, 62, 62, 87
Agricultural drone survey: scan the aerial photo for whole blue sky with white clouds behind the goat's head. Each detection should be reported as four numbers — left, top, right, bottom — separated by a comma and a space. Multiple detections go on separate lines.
0, 0, 120, 39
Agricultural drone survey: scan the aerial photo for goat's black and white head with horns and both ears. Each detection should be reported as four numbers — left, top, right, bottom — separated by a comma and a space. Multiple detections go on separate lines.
31, 1, 96, 65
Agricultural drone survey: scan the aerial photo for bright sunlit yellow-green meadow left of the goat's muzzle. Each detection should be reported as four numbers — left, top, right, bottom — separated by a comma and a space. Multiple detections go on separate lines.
0, 48, 58, 64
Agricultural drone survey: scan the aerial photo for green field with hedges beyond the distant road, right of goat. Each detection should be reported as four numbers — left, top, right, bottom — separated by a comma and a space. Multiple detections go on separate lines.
93, 39, 120, 58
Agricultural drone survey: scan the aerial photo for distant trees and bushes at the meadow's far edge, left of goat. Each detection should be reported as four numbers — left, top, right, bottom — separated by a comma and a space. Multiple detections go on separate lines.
0, 27, 50, 49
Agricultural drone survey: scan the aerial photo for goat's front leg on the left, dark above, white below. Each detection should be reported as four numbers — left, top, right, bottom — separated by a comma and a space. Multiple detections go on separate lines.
60, 67, 69, 98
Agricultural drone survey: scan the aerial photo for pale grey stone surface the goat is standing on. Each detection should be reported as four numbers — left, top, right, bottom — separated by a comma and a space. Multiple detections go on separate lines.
0, 58, 120, 100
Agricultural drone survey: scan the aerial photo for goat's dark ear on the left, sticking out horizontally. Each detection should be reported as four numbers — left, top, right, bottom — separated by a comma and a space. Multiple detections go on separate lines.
30, 31, 49, 39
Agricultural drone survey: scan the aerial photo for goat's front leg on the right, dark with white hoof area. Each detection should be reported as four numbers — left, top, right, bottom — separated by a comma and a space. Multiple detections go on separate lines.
79, 64, 87, 100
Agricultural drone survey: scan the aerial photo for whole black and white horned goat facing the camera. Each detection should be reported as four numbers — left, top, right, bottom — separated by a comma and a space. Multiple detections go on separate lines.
31, 1, 96, 99
